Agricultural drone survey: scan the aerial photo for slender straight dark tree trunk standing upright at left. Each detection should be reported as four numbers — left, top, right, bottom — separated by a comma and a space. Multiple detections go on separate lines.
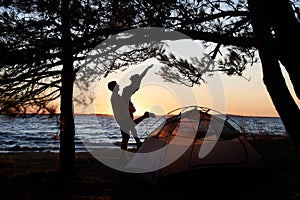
60, 0, 76, 178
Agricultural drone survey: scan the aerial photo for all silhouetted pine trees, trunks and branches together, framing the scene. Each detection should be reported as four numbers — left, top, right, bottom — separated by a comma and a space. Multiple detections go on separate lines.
0, 0, 300, 176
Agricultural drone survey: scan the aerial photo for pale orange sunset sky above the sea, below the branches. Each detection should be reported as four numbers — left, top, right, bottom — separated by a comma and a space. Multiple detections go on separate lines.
74, 38, 300, 117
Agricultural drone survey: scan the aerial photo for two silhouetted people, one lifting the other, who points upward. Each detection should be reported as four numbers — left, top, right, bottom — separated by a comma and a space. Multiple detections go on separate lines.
108, 65, 153, 150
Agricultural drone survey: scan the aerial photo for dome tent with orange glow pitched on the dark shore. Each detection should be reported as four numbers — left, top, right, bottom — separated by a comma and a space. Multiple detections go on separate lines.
126, 106, 268, 177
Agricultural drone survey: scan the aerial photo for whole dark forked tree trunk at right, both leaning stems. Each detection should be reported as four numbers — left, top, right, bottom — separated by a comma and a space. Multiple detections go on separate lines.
248, 0, 300, 146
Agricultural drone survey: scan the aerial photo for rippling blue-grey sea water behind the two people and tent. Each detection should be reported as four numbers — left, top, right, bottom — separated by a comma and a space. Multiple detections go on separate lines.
0, 115, 286, 153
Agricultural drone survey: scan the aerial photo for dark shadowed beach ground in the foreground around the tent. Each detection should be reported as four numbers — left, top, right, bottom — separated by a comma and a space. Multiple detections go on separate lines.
0, 136, 300, 200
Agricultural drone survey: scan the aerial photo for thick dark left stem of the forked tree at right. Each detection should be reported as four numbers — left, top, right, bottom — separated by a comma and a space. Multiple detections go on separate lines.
248, 0, 300, 147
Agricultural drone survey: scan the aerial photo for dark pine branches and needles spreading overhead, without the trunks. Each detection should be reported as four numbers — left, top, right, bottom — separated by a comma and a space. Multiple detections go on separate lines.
0, 0, 299, 110
